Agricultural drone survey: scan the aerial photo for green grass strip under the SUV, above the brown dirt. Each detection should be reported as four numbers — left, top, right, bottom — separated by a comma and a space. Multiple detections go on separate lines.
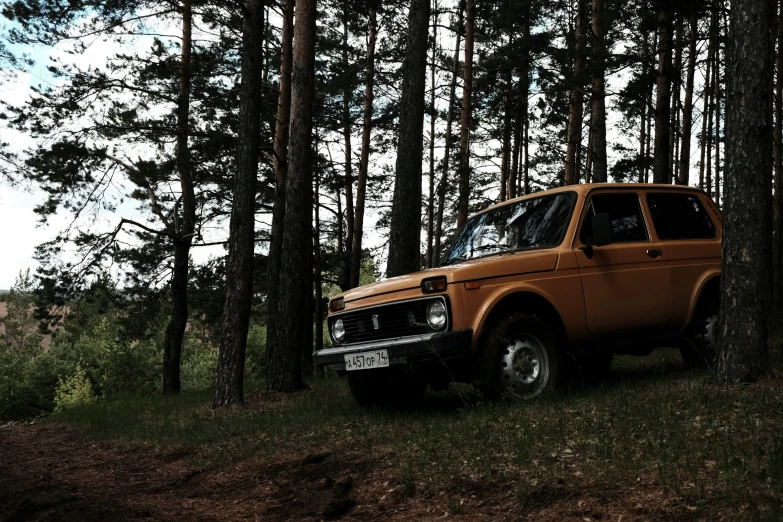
51, 350, 783, 520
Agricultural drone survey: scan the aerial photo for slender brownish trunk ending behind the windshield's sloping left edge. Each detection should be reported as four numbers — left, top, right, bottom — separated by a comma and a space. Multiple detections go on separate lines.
457, 0, 475, 228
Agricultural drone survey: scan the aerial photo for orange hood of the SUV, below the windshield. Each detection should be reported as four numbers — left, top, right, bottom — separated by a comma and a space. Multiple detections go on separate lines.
335, 250, 559, 303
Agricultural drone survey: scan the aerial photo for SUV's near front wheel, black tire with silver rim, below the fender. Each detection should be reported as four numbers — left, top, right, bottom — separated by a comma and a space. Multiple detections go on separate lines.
474, 313, 564, 400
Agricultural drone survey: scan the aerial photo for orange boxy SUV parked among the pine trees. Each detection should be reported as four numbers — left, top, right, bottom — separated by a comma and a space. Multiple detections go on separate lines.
313, 184, 722, 405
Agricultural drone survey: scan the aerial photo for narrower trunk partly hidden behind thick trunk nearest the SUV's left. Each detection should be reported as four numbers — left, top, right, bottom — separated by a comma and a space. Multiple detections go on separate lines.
265, 0, 296, 382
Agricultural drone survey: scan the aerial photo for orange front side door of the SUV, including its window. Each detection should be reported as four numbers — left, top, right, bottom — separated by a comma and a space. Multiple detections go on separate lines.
574, 190, 672, 334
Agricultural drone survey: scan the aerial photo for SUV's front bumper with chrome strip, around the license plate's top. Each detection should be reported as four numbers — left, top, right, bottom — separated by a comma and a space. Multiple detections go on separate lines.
313, 328, 473, 370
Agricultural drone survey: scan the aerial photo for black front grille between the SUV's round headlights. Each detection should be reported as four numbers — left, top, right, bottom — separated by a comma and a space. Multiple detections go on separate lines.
329, 297, 449, 345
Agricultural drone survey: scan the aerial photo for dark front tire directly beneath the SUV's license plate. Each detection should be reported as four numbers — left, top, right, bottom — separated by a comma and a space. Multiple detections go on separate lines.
348, 368, 427, 408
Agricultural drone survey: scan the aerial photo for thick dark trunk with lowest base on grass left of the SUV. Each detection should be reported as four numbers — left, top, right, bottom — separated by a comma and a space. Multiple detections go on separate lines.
212, 0, 264, 407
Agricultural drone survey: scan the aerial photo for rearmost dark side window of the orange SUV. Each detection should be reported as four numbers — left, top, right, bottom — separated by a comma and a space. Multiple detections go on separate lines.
647, 192, 717, 240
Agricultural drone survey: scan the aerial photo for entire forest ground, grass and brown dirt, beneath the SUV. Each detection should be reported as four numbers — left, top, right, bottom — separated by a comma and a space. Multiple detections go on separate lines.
0, 350, 783, 522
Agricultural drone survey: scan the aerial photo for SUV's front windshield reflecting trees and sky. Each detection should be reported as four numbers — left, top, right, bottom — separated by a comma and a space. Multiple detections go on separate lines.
441, 192, 576, 265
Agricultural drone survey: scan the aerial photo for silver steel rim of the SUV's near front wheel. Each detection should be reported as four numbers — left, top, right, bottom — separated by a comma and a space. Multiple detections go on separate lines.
500, 335, 549, 399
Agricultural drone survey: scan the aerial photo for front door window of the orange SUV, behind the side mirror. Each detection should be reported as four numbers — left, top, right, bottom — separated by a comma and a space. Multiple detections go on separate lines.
579, 194, 650, 244
